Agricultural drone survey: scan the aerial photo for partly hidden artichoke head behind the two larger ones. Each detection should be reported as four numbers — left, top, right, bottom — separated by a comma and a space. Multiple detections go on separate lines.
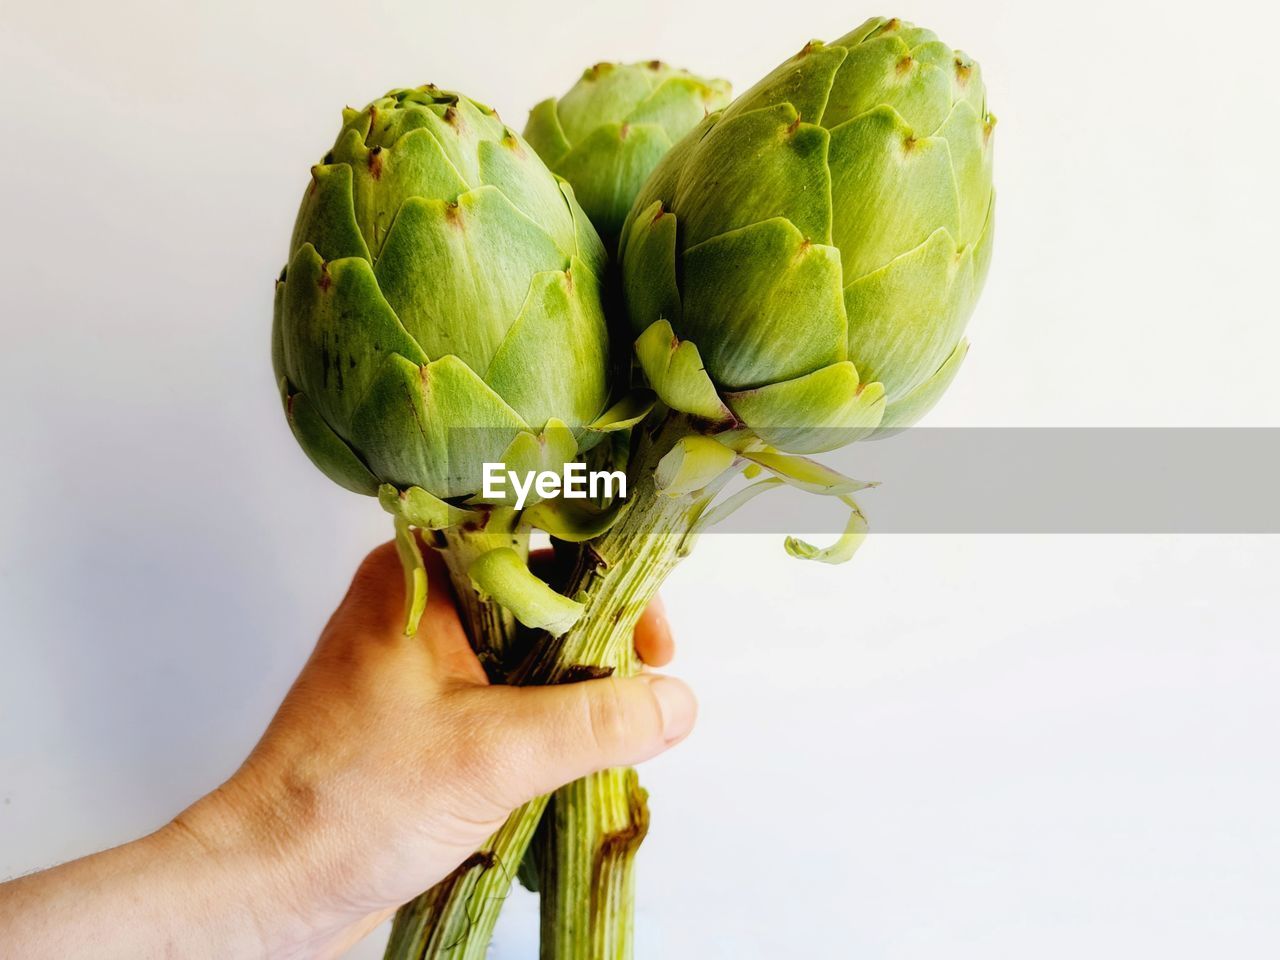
525, 60, 730, 250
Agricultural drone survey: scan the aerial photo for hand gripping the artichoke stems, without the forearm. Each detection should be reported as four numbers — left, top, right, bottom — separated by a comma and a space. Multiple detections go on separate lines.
169, 544, 696, 956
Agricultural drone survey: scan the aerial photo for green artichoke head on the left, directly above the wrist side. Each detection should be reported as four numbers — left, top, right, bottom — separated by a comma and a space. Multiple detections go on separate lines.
271, 86, 608, 502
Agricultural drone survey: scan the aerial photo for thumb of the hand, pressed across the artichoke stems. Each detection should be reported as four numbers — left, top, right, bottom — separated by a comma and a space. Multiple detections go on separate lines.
470, 673, 698, 806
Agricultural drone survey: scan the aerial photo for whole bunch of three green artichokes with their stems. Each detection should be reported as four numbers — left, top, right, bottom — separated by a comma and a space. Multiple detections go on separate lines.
273, 18, 995, 960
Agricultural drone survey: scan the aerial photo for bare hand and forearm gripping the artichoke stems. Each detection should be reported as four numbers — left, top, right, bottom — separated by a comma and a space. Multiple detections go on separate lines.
0, 544, 696, 960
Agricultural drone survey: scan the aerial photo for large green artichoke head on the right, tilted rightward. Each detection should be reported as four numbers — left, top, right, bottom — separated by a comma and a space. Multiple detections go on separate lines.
621, 19, 995, 453
